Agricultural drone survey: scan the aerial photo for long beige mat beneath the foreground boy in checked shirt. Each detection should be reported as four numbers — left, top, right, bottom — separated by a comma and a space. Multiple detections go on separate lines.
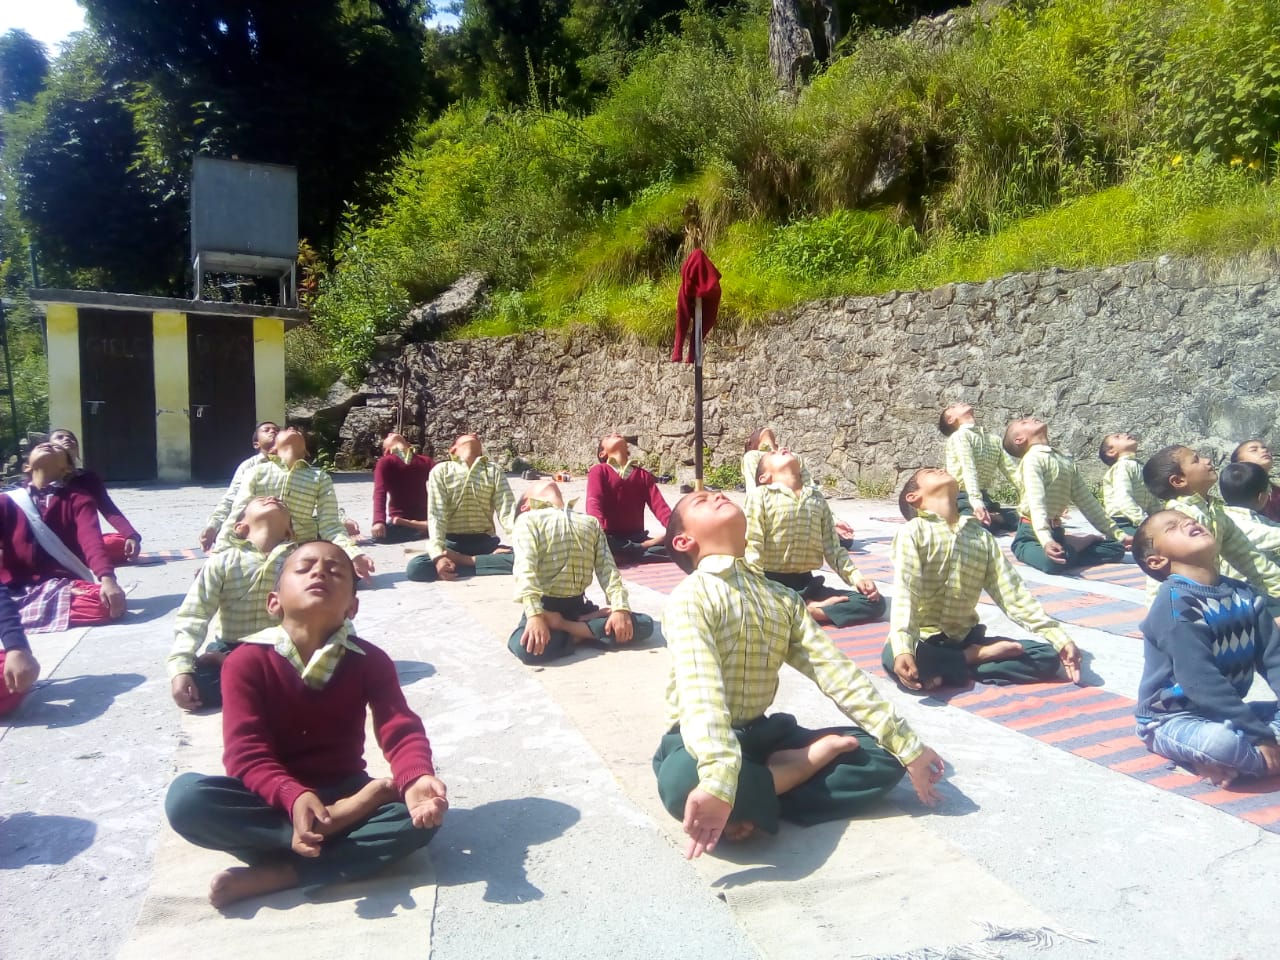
443, 577, 1062, 960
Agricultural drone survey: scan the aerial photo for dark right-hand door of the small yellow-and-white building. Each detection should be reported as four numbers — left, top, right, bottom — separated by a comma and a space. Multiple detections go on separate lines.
187, 314, 257, 483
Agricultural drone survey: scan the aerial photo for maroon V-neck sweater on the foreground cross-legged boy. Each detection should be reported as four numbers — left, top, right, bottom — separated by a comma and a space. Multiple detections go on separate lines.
221, 636, 435, 817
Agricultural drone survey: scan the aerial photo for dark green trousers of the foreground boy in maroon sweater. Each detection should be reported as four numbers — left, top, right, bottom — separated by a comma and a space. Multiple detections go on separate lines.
164, 773, 435, 893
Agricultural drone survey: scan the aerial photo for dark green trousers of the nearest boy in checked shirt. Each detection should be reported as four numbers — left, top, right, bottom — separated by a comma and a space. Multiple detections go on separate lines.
653, 713, 906, 833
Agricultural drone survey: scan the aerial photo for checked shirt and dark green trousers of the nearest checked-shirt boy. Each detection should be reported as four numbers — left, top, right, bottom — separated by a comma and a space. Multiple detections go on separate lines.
653, 556, 924, 833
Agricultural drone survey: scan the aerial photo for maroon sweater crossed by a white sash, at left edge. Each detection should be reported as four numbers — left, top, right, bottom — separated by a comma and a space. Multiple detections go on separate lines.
0, 486, 115, 590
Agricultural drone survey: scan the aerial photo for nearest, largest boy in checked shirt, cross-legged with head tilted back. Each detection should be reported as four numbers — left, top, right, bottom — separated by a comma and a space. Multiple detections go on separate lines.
653, 490, 945, 858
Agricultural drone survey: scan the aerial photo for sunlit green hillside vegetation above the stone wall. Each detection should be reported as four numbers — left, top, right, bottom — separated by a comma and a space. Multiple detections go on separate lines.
307, 0, 1280, 378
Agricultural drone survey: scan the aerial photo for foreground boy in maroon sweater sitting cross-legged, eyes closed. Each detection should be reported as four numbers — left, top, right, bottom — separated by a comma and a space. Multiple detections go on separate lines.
165, 540, 449, 908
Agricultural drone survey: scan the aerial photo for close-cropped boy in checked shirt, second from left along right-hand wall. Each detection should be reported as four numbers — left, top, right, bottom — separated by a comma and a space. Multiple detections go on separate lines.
1005, 417, 1133, 573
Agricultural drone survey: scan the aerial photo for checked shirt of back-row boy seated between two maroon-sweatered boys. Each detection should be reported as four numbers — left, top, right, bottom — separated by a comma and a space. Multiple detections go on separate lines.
426, 457, 516, 559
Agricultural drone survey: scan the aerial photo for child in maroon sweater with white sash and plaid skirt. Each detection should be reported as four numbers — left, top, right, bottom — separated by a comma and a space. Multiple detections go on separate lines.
0, 443, 124, 634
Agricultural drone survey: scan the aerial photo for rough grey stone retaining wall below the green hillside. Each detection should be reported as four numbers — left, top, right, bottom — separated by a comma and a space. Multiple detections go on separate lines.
343, 259, 1280, 492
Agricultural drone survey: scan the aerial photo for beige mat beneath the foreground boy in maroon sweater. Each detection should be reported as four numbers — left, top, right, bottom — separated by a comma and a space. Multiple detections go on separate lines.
118, 714, 435, 960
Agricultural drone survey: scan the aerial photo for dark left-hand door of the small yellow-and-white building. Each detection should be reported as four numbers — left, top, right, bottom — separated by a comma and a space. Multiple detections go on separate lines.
76, 307, 156, 480
